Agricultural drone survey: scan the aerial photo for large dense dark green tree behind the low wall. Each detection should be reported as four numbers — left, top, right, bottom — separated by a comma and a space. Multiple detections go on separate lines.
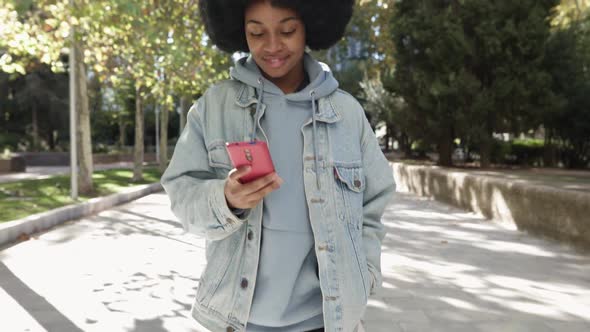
391, 0, 557, 167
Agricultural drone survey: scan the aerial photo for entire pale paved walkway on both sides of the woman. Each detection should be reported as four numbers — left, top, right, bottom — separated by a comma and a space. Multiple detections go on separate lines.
0, 193, 590, 332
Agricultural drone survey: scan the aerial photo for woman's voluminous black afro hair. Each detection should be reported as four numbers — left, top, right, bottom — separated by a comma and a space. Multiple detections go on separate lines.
199, 0, 354, 53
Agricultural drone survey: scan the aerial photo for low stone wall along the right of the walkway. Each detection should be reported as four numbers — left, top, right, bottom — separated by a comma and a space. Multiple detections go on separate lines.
390, 162, 590, 252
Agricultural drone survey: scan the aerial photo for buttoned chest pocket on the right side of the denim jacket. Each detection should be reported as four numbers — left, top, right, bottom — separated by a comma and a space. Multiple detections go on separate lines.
334, 163, 366, 229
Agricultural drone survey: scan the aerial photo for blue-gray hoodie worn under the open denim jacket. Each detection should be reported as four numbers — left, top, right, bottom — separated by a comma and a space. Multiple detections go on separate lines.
231, 53, 338, 332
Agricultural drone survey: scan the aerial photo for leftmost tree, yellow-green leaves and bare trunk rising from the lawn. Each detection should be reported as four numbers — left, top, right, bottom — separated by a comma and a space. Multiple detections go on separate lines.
0, 0, 93, 193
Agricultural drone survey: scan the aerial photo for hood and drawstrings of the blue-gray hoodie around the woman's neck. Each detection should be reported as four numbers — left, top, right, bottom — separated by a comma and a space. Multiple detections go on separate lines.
230, 52, 338, 189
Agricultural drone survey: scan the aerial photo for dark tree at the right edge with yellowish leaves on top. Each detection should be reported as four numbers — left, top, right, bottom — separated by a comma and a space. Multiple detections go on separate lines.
542, 1, 590, 168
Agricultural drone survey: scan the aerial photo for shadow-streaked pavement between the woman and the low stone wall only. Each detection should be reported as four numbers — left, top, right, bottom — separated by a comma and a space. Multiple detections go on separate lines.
365, 193, 590, 332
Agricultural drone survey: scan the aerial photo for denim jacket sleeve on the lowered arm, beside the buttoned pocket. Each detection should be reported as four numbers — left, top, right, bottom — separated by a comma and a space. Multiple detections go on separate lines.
361, 115, 395, 295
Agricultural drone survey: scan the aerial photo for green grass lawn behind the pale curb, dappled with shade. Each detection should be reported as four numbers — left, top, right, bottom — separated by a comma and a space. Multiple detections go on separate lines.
0, 167, 160, 223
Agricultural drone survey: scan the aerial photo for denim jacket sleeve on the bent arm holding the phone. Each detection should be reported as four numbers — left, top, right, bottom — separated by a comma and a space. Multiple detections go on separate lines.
161, 98, 249, 240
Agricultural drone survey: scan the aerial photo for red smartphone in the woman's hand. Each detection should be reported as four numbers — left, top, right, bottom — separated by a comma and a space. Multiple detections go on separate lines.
225, 141, 275, 183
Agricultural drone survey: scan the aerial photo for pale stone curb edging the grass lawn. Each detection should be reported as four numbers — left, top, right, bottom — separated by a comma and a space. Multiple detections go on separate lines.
0, 183, 163, 250
